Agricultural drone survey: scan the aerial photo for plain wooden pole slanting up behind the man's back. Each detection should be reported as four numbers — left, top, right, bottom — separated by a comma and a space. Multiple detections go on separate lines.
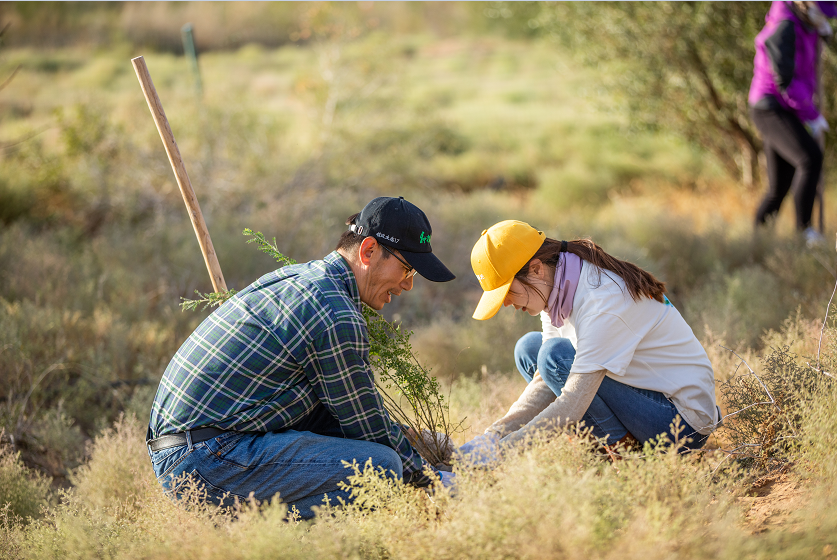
131, 56, 227, 292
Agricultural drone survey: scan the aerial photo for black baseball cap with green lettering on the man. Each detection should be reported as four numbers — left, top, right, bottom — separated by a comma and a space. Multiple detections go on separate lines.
351, 196, 456, 282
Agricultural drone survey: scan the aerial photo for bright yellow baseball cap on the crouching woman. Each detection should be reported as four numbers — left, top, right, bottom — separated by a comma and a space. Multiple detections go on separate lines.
471, 220, 546, 321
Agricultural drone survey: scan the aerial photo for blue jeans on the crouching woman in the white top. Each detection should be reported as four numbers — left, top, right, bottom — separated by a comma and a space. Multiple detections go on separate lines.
514, 332, 706, 449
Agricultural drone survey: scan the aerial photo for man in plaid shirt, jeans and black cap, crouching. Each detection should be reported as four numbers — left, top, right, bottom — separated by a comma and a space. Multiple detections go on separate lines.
148, 197, 454, 518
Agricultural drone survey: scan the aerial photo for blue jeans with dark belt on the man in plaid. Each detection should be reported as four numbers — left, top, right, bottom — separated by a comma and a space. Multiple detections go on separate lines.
151, 430, 402, 519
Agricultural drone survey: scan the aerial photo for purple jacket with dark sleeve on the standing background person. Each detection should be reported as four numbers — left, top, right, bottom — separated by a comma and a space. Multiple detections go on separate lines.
748, 2, 820, 122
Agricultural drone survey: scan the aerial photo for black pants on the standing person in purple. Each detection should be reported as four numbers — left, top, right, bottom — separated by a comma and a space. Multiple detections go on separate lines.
750, 108, 822, 230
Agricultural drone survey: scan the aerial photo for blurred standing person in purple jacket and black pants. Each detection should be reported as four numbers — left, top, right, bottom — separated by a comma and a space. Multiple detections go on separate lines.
748, 2, 837, 245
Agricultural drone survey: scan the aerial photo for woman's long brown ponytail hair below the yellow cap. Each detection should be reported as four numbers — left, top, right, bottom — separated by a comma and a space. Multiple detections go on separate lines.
514, 237, 666, 303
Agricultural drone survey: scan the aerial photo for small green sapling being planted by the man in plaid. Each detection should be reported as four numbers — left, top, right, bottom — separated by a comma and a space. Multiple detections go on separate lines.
180, 228, 464, 465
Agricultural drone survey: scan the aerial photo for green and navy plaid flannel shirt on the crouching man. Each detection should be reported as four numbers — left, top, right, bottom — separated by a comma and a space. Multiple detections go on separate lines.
150, 251, 428, 484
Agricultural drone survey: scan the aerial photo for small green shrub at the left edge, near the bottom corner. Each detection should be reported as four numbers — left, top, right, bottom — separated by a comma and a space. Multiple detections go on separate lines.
0, 440, 50, 526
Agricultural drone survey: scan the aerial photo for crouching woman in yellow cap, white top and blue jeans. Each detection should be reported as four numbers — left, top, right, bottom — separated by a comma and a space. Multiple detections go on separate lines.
460, 220, 720, 458
